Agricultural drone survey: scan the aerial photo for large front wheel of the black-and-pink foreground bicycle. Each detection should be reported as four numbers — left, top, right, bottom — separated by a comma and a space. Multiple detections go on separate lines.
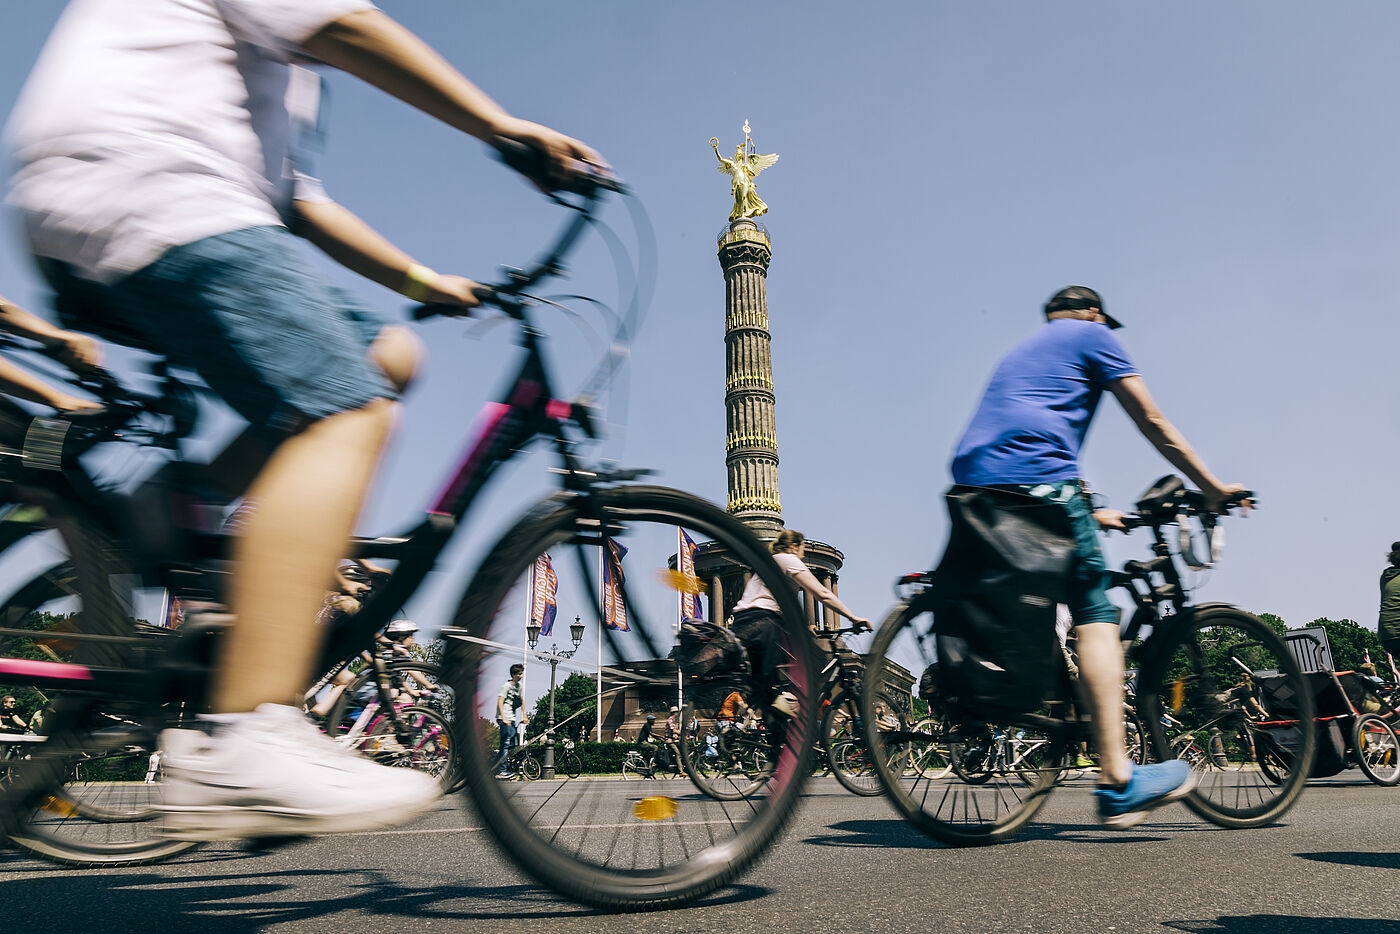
444, 486, 818, 909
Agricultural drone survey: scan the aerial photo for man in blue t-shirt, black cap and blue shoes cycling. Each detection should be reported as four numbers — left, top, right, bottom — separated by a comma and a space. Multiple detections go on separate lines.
952, 286, 1252, 829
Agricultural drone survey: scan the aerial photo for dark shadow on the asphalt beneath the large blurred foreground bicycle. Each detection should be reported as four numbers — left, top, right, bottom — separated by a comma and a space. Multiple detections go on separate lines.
0, 854, 770, 934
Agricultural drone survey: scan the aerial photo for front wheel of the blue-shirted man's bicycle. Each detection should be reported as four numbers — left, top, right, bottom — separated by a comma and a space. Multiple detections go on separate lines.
1138, 605, 1316, 829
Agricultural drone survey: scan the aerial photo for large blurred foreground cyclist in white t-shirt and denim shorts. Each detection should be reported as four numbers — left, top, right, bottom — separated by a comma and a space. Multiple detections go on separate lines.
6, 0, 601, 840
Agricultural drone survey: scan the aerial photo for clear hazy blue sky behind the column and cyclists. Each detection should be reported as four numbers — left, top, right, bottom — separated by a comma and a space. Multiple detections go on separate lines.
0, 0, 1400, 658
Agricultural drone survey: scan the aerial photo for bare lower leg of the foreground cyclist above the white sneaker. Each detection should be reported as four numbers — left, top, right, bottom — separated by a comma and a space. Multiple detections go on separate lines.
211, 399, 398, 713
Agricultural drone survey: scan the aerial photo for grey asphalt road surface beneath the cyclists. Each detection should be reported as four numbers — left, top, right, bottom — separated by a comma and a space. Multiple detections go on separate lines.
0, 770, 1400, 934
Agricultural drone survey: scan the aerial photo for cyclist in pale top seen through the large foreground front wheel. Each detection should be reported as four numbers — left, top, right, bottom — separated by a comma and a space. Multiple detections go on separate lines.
734, 529, 871, 717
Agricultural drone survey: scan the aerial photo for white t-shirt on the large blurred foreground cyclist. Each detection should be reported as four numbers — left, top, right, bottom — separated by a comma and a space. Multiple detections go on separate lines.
6, 0, 375, 281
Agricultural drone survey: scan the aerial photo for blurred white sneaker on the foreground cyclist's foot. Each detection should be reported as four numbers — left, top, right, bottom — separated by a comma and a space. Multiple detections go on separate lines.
161, 704, 441, 840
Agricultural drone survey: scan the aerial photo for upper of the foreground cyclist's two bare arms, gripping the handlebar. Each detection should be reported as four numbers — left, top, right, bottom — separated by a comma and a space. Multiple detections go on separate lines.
302, 10, 608, 182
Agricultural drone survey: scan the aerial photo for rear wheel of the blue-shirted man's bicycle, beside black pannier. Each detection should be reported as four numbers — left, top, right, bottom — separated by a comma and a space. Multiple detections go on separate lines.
864, 592, 1065, 847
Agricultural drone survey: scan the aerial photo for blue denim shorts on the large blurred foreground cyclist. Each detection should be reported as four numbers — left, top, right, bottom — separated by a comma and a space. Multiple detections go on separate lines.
39, 227, 395, 441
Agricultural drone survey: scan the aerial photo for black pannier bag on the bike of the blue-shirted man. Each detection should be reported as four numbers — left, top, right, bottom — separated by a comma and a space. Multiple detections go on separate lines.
932, 486, 1075, 717
